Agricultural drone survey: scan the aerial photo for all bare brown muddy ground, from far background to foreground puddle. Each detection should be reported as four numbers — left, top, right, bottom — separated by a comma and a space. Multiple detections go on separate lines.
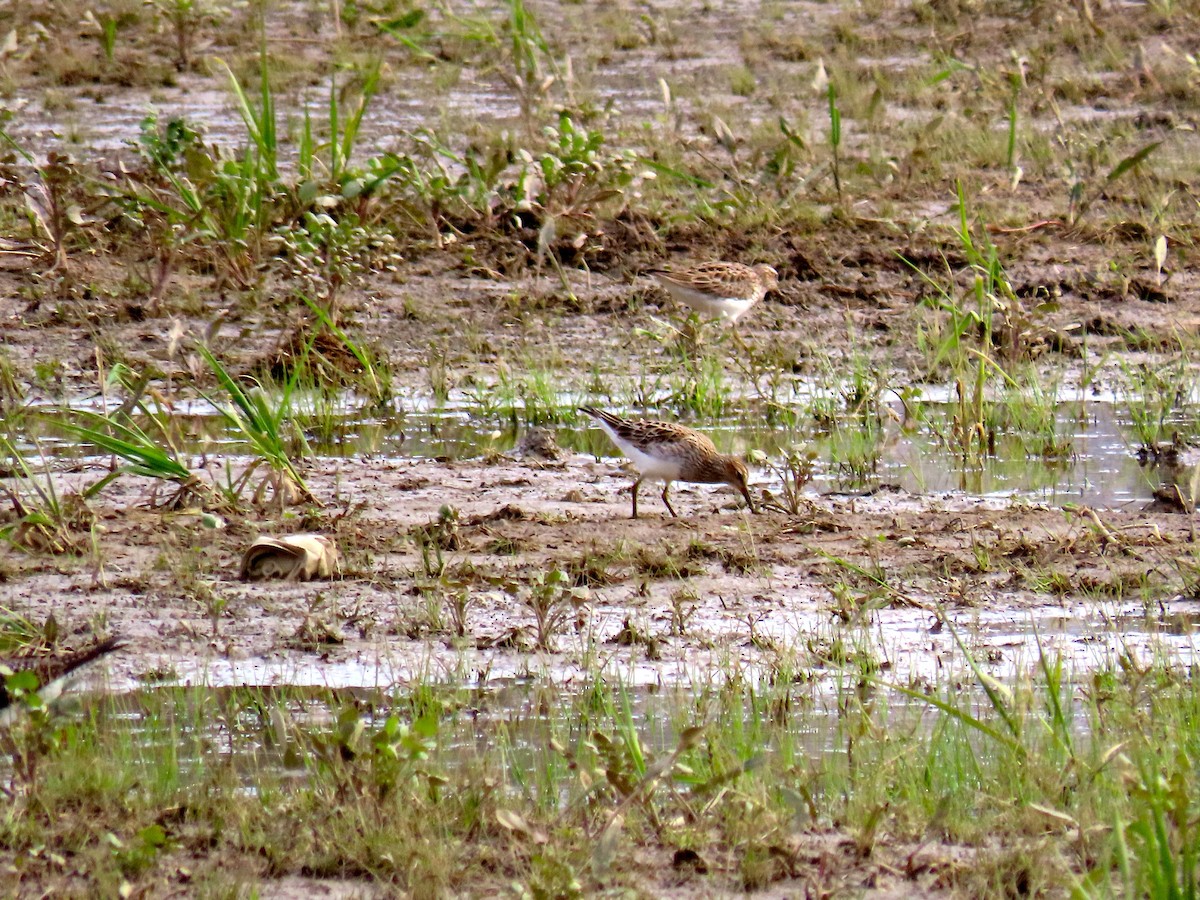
0, 2, 1200, 894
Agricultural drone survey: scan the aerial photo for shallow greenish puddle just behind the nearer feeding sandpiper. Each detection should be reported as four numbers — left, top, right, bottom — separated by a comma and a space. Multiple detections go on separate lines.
18, 397, 1194, 509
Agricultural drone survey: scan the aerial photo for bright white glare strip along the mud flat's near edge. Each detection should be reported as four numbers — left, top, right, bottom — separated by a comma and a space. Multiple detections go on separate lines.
105, 593, 1200, 692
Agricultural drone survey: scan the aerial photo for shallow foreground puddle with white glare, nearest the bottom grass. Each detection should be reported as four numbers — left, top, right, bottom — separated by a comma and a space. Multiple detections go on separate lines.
39, 599, 1200, 790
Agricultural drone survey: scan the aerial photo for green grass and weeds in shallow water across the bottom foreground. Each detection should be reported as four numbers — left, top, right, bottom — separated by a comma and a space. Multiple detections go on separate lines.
0, 643, 1200, 896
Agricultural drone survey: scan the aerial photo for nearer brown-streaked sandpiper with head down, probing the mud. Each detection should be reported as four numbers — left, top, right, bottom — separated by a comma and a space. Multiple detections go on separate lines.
580, 407, 755, 518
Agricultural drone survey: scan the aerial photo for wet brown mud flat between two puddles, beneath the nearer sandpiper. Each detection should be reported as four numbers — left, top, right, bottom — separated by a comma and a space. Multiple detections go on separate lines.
7, 454, 1198, 690
